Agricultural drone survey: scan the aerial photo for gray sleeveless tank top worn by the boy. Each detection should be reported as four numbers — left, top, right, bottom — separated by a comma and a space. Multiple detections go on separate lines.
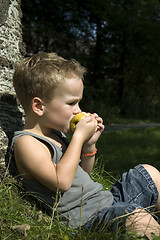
10, 130, 113, 228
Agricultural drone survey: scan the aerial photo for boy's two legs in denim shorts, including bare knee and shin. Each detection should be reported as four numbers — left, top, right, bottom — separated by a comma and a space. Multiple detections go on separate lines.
86, 165, 160, 239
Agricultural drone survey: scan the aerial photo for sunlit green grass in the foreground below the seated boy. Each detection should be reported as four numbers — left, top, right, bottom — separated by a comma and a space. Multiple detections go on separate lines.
0, 177, 144, 240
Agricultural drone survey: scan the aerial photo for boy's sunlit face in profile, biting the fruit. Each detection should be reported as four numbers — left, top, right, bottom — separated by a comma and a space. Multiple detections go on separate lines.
43, 77, 83, 133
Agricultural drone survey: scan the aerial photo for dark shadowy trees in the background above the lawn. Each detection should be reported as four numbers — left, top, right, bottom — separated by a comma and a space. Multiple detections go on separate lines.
21, 0, 160, 118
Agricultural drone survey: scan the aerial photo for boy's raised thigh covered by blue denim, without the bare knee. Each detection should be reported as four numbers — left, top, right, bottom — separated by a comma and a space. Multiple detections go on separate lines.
111, 164, 158, 208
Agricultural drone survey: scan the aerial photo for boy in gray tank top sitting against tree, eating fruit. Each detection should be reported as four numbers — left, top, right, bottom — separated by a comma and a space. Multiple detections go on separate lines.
11, 53, 160, 239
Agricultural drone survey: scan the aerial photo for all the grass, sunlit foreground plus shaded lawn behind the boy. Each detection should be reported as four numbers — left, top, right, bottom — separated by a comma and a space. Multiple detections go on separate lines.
0, 128, 160, 240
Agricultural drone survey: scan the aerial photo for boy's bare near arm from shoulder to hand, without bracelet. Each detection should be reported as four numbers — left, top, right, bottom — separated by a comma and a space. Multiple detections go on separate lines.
15, 115, 95, 191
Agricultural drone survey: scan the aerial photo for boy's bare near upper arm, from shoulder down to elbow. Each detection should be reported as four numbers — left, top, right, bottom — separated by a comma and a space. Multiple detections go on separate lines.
14, 135, 56, 186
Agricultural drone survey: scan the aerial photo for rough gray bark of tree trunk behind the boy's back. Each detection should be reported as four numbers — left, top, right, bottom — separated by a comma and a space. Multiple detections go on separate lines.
0, 0, 25, 181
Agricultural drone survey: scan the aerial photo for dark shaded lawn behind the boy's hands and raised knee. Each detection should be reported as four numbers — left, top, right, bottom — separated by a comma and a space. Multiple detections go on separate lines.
97, 127, 160, 177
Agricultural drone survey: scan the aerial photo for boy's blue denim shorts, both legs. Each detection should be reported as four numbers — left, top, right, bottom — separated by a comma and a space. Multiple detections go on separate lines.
84, 164, 158, 232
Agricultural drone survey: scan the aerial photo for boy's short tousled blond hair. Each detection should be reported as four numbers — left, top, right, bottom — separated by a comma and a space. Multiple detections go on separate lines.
13, 52, 86, 111
